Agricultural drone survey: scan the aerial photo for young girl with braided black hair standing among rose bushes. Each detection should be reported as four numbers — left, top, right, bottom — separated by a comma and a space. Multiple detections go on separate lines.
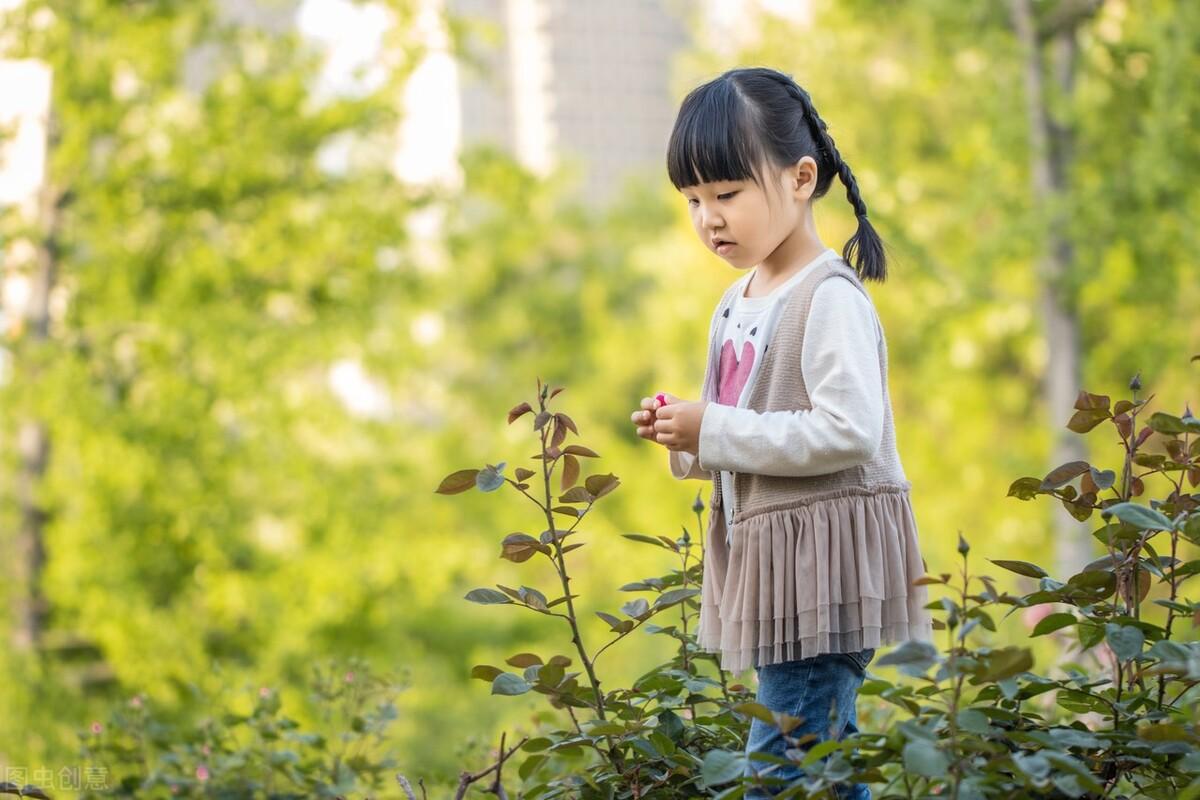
632, 67, 932, 798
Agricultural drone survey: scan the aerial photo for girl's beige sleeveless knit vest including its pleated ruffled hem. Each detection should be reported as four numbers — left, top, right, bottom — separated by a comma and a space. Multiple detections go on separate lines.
697, 253, 932, 673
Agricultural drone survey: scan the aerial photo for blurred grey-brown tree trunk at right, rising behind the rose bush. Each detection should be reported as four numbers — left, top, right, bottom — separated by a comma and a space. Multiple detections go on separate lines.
1009, 0, 1100, 578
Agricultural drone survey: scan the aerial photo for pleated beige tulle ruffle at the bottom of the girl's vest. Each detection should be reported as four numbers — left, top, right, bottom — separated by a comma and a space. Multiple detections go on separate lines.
697, 482, 932, 673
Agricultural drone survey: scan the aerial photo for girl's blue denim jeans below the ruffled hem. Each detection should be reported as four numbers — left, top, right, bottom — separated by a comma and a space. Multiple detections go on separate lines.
743, 648, 875, 800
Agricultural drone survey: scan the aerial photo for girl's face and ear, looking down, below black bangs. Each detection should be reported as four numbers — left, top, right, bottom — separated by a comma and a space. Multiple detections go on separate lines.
680, 156, 816, 270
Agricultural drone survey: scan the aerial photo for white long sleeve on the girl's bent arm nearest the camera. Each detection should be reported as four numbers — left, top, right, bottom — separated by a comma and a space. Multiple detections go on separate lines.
696, 279, 884, 476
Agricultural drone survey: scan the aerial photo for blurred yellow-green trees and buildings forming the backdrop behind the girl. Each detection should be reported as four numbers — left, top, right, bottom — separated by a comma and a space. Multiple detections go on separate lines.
0, 0, 1200, 780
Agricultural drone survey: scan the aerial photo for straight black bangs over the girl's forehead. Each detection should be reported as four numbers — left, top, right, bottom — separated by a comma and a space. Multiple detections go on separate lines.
667, 80, 763, 190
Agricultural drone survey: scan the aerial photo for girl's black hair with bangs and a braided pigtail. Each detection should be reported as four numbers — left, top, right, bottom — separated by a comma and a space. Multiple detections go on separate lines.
667, 67, 887, 281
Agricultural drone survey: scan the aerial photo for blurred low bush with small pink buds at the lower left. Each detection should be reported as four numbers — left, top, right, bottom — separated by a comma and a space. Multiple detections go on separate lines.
79, 658, 401, 800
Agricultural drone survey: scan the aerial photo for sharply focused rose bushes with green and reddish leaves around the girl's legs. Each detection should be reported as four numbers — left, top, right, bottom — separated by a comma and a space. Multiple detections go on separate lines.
437, 371, 1200, 800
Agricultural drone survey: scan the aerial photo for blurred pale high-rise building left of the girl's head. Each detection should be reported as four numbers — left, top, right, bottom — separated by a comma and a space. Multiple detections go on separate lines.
446, 0, 690, 201
